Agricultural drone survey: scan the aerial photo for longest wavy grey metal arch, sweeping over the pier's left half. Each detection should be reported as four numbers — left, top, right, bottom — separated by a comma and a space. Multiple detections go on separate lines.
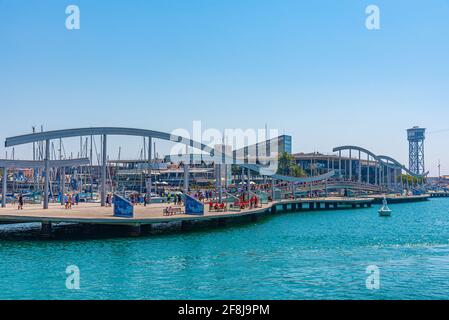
5, 127, 335, 183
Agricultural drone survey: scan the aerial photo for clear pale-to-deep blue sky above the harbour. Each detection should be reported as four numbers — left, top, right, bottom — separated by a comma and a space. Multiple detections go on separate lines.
0, 0, 449, 174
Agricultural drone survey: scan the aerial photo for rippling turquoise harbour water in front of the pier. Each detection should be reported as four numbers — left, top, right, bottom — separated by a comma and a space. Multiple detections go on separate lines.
0, 199, 449, 299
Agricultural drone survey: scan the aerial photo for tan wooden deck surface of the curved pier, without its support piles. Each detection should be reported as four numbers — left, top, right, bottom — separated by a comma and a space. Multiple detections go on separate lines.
0, 198, 373, 225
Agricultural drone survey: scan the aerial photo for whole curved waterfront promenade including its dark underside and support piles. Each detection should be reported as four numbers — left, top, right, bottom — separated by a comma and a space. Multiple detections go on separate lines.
0, 195, 429, 235
